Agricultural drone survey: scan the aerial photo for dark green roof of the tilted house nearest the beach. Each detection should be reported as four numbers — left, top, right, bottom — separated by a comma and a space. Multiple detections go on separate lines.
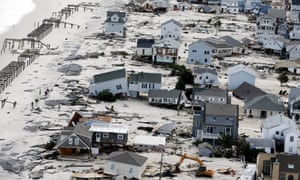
93, 69, 126, 83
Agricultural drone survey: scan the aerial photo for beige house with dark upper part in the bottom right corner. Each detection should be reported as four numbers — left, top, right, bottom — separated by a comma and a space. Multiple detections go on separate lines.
256, 153, 300, 180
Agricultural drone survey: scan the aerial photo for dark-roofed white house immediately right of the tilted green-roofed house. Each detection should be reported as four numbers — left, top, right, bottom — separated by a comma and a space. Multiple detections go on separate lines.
128, 72, 161, 97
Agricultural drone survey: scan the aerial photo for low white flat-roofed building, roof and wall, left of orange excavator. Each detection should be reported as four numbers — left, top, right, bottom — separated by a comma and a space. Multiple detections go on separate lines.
133, 135, 166, 151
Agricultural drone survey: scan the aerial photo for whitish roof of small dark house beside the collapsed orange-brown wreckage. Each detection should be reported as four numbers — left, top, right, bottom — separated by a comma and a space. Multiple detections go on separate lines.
89, 123, 128, 134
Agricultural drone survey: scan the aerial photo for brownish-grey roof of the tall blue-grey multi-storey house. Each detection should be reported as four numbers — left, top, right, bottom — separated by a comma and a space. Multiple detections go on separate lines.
205, 103, 238, 116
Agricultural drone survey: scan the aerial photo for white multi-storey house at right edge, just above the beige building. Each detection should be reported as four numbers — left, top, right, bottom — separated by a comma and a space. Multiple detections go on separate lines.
261, 114, 299, 154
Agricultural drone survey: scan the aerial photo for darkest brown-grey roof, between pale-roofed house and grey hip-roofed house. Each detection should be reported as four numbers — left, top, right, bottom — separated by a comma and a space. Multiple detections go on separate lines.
232, 82, 266, 100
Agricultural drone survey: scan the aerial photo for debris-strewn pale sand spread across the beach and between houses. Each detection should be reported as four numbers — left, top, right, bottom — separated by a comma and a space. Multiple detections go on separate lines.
0, 0, 296, 180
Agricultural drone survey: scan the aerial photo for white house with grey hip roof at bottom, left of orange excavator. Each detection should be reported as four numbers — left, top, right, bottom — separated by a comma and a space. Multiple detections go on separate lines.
104, 151, 148, 179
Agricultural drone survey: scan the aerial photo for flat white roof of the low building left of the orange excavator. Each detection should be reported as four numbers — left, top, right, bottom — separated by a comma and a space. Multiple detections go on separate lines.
134, 135, 166, 146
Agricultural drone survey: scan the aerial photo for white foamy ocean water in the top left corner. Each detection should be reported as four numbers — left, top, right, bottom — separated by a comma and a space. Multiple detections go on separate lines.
0, 0, 35, 34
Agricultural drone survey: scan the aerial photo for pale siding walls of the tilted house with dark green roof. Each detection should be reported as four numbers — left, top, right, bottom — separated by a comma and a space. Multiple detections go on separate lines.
89, 77, 128, 96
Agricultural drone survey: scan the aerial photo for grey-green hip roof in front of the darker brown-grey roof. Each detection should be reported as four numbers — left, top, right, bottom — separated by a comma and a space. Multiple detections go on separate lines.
245, 94, 285, 112
